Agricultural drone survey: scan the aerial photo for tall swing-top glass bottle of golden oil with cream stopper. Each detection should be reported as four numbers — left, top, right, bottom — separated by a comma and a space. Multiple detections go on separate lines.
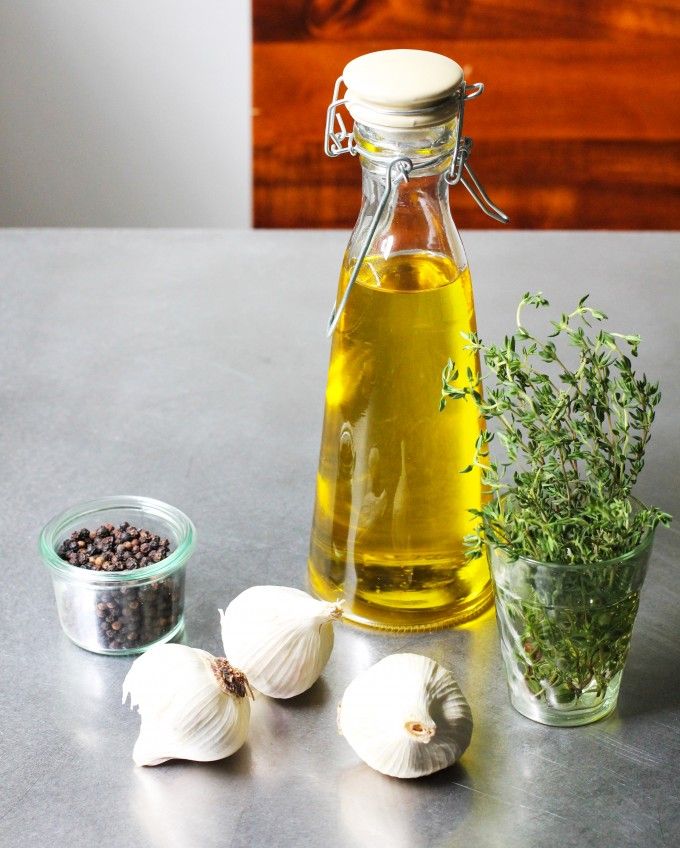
309, 50, 507, 629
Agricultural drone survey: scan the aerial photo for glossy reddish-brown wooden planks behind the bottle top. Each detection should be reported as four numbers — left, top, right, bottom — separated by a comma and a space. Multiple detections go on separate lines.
253, 0, 680, 230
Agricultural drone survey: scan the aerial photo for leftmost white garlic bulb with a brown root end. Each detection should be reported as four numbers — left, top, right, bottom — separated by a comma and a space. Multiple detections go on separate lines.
123, 644, 251, 766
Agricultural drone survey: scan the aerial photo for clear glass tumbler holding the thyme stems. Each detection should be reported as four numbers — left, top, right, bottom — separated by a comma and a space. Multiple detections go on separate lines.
489, 530, 654, 727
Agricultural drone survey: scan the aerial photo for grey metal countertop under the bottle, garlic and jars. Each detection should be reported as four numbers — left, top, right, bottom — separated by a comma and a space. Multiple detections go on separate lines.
0, 230, 680, 848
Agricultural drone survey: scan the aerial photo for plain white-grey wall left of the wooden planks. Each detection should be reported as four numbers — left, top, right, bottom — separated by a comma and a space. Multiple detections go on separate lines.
0, 0, 251, 227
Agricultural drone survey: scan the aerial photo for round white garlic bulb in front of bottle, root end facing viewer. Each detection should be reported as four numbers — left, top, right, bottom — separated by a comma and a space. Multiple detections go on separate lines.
338, 654, 472, 777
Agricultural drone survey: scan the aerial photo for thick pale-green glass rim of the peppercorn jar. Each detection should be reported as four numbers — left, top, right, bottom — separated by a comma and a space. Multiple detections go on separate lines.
38, 495, 196, 585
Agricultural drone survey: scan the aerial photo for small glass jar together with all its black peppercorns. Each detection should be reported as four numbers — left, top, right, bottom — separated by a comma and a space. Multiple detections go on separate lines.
40, 496, 196, 654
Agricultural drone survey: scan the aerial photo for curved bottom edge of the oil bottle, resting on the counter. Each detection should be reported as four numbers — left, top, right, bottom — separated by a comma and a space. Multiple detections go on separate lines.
308, 565, 493, 632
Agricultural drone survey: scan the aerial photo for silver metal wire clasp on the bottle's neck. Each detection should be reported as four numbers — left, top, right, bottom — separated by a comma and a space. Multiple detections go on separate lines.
324, 76, 510, 336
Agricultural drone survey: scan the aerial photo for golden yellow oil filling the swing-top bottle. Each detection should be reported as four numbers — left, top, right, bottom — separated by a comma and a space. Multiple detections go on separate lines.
309, 252, 491, 629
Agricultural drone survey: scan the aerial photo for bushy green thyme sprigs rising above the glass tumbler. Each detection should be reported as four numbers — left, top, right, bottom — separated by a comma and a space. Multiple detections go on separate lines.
440, 292, 670, 563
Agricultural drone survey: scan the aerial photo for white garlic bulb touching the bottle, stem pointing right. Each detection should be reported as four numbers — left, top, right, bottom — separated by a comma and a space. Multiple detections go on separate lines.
220, 586, 342, 698
